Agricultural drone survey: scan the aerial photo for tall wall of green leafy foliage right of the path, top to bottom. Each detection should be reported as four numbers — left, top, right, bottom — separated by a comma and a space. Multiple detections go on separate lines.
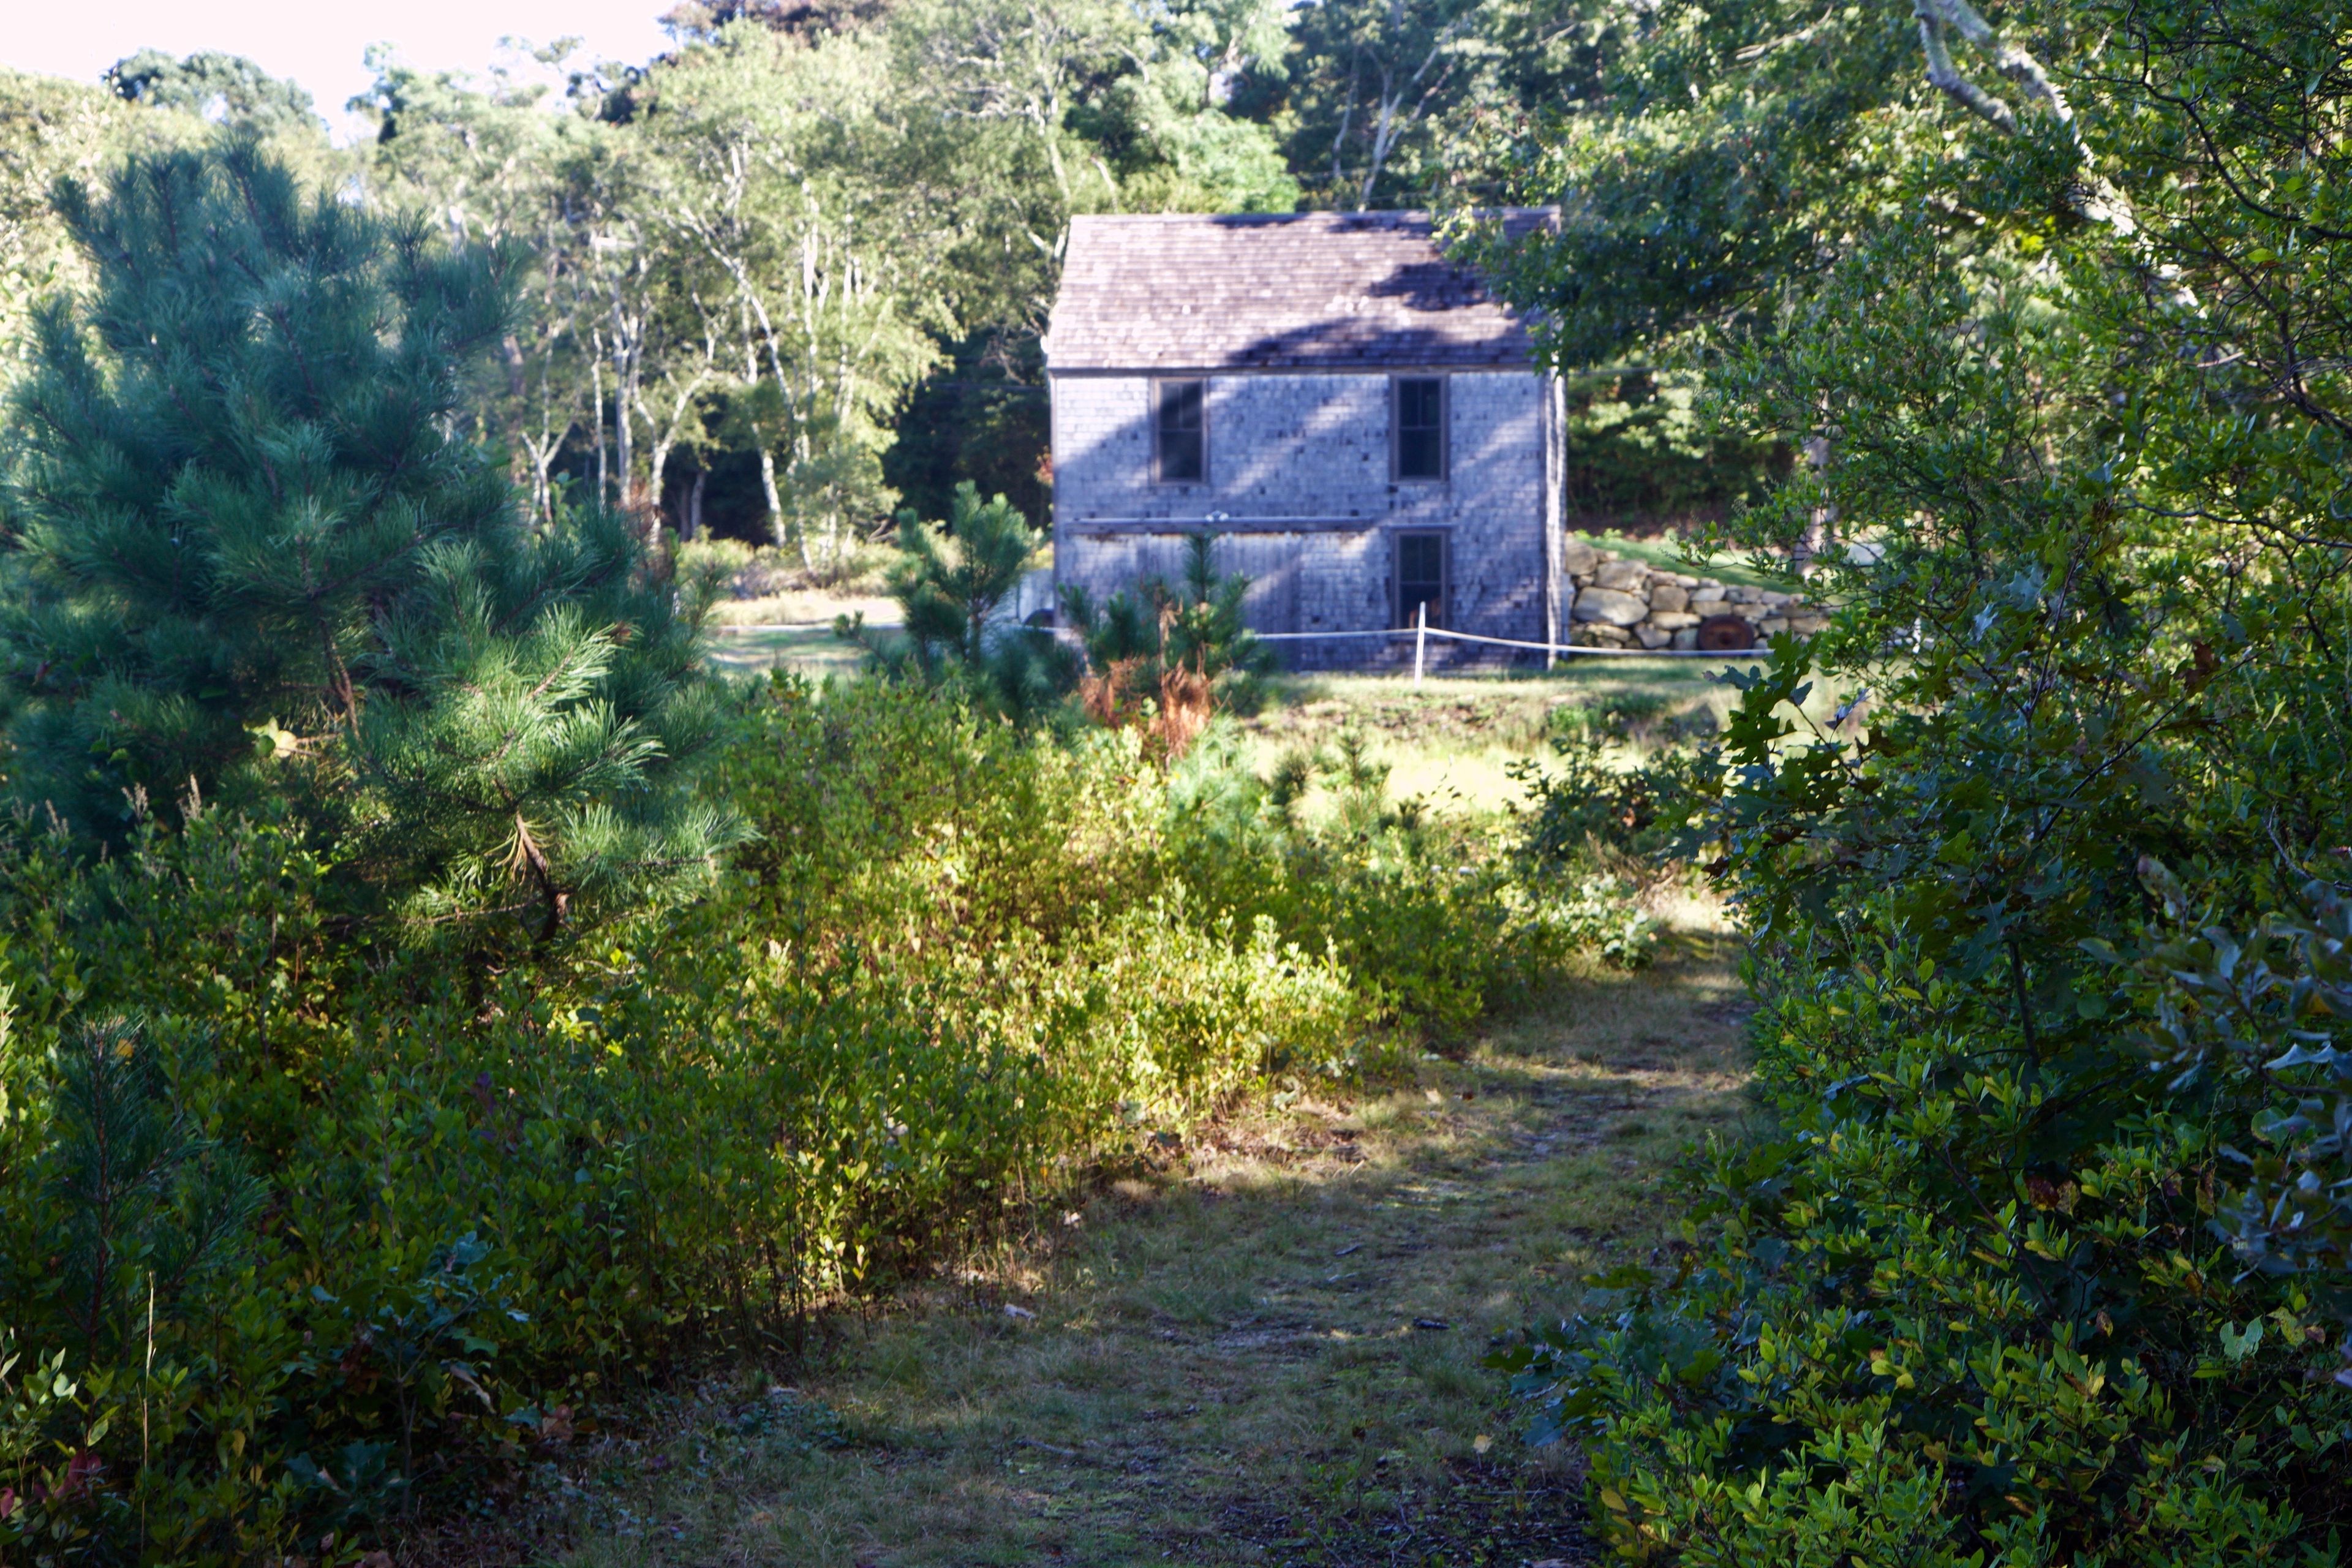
1506, 0, 2352, 1563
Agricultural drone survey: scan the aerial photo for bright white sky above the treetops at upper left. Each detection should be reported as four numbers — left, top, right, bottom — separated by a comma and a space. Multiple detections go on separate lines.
0, 0, 670, 138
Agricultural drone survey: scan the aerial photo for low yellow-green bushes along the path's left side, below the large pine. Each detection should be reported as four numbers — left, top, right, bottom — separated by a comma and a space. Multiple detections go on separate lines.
0, 679, 1637, 1561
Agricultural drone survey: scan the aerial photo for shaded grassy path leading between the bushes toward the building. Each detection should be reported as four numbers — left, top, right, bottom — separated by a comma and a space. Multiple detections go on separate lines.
491, 938, 1741, 1568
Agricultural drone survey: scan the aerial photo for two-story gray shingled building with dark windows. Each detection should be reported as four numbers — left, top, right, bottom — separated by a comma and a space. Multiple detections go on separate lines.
1044, 211, 1569, 668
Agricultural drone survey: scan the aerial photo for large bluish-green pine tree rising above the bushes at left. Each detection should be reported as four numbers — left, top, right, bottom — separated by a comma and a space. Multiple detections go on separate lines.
0, 134, 734, 938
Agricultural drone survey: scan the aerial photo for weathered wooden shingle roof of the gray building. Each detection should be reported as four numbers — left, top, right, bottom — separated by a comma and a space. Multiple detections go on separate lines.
1044, 209, 1552, 371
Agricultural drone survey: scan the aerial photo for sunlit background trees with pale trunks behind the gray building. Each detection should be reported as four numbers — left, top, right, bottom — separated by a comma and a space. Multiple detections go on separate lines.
0, 0, 1768, 576
